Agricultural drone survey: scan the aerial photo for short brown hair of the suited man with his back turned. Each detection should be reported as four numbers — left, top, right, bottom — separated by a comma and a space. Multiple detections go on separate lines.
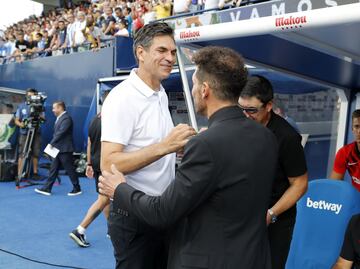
193, 46, 248, 103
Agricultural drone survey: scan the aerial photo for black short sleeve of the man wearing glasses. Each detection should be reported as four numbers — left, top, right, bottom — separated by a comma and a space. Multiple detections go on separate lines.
280, 130, 307, 177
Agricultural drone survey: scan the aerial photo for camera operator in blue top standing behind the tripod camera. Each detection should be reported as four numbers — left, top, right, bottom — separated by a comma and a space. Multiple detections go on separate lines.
15, 88, 45, 180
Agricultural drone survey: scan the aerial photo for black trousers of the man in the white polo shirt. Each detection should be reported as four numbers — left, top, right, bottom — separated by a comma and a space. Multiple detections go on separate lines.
108, 205, 168, 269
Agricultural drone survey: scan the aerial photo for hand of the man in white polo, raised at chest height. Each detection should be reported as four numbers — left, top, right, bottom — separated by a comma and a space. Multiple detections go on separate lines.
161, 124, 197, 154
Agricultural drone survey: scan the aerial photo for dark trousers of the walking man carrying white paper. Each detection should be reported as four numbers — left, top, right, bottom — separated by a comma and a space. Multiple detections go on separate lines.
44, 152, 80, 191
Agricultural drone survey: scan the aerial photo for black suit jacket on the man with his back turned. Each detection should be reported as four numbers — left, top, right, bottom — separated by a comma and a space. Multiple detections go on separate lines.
113, 106, 277, 269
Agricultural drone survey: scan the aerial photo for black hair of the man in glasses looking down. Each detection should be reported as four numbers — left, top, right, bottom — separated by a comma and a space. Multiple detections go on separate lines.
240, 75, 274, 104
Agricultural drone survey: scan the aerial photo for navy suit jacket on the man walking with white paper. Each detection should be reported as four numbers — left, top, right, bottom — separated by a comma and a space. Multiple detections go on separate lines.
50, 112, 74, 153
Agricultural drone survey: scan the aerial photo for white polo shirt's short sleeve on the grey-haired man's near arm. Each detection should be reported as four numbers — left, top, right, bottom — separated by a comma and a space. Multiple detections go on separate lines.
101, 89, 137, 146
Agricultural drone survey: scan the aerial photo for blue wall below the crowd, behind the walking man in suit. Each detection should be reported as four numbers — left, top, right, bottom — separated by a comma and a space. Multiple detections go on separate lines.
0, 48, 114, 151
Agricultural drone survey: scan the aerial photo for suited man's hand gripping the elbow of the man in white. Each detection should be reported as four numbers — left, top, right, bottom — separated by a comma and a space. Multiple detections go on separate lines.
99, 164, 126, 199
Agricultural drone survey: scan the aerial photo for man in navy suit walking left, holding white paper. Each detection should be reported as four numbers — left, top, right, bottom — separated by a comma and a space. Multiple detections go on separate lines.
35, 101, 81, 196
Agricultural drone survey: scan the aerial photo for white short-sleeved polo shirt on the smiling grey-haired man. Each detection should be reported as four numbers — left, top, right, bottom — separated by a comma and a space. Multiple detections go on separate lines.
101, 69, 176, 196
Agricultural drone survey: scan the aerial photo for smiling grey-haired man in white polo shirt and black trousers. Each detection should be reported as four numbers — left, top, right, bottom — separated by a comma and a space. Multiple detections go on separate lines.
101, 23, 196, 269
